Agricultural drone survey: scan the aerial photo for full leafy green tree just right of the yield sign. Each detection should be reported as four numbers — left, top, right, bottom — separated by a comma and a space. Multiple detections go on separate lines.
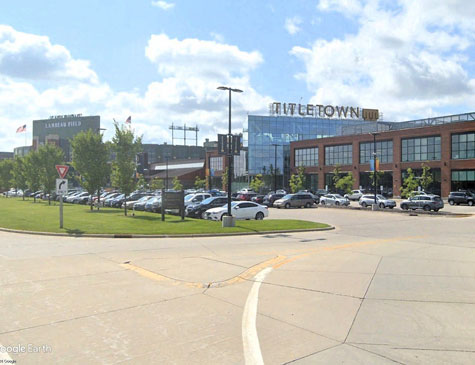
71, 129, 110, 210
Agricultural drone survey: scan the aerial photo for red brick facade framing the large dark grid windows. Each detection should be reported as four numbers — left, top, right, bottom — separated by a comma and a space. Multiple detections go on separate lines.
290, 121, 475, 197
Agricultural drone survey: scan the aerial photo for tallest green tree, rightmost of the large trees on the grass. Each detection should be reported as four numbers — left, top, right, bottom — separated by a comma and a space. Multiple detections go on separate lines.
112, 123, 142, 215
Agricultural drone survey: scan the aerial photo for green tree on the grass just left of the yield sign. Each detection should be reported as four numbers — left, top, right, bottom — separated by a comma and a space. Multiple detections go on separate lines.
38, 144, 64, 205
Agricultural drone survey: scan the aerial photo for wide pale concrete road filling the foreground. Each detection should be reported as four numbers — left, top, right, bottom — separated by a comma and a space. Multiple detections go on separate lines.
0, 208, 475, 364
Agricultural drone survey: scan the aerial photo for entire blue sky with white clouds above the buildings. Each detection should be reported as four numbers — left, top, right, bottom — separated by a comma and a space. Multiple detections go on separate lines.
0, 0, 475, 151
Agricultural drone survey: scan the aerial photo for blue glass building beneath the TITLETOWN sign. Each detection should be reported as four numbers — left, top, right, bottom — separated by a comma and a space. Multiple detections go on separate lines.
248, 115, 382, 185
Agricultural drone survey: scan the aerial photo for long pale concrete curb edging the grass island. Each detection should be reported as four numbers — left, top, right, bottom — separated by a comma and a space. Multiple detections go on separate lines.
0, 226, 335, 238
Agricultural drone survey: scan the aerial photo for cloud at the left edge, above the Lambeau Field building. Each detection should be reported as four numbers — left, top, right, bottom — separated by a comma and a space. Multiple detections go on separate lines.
0, 25, 97, 83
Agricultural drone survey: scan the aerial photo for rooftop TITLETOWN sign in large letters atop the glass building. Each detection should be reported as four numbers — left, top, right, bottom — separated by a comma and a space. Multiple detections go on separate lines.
269, 102, 379, 121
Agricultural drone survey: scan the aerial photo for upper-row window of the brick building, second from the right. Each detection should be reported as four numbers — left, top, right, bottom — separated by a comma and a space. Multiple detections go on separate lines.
401, 136, 440, 162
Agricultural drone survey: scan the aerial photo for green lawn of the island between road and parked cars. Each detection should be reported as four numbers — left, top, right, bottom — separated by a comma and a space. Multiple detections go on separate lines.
0, 198, 329, 235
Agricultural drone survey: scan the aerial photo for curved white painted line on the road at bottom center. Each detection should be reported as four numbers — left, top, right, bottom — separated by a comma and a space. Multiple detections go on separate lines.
242, 267, 272, 365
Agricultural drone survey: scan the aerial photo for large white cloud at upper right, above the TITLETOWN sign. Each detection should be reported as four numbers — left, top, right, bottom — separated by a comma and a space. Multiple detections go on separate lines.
290, 0, 475, 120
